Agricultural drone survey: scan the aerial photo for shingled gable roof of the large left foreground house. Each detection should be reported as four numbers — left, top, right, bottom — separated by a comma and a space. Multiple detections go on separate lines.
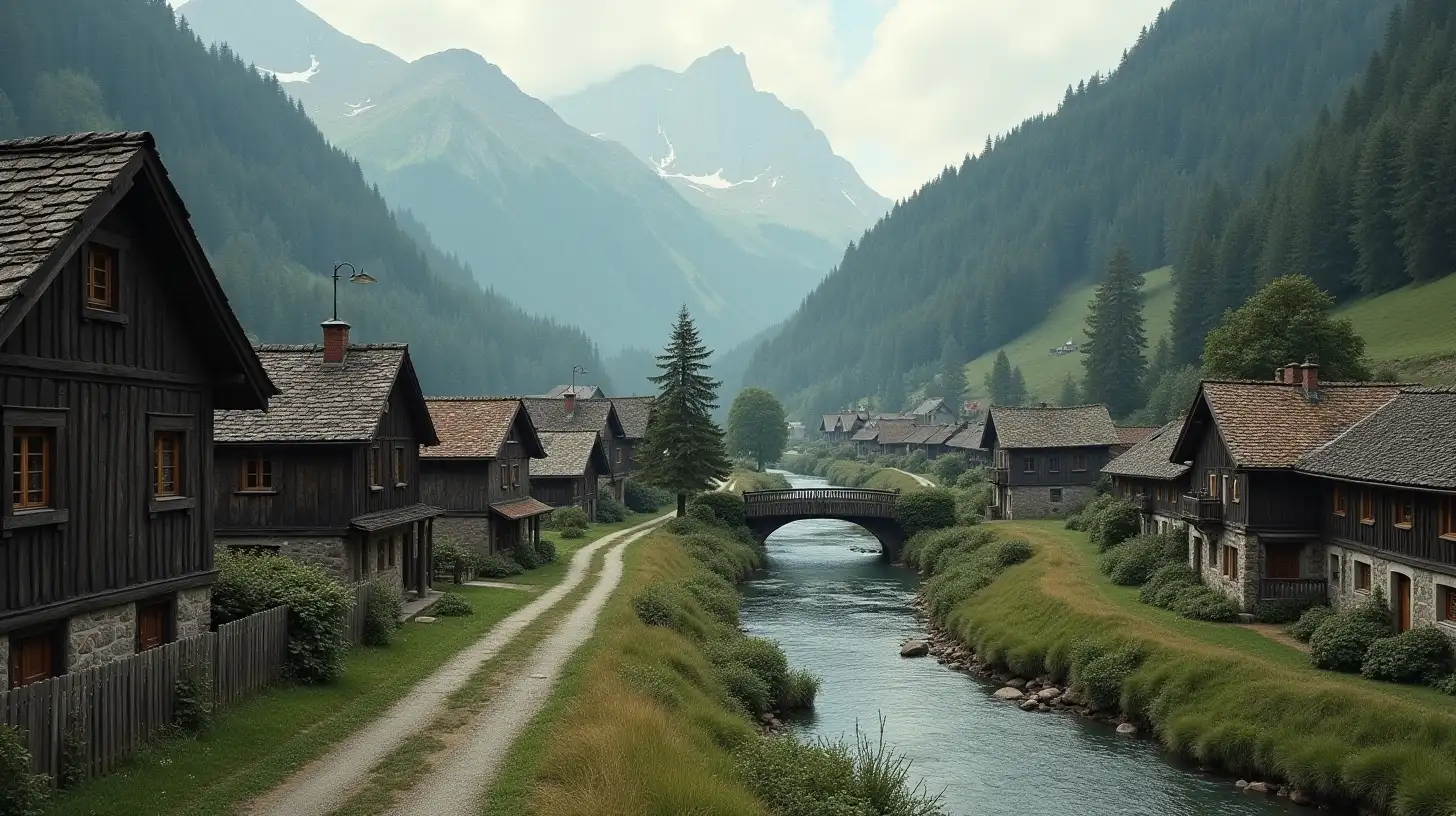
0, 133, 277, 408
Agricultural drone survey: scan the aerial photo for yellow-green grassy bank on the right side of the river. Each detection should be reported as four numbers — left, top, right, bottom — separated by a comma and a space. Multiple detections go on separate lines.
946, 522, 1456, 816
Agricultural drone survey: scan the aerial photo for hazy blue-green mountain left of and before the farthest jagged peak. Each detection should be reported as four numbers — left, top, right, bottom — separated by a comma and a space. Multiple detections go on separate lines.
182, 0, 834, 351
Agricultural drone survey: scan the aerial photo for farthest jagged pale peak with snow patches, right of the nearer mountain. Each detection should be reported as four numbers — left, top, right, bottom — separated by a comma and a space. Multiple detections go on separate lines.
552, 48, 891, 248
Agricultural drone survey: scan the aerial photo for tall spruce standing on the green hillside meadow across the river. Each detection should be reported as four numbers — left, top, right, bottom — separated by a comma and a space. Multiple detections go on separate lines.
1082, 248, 1147, 417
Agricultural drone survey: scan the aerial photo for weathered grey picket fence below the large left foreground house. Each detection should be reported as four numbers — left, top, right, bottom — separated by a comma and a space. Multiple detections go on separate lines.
0, 606, 288, 784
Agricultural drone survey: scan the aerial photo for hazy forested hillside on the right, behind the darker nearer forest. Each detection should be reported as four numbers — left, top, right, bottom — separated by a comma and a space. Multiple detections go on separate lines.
748, 0, 1395, 412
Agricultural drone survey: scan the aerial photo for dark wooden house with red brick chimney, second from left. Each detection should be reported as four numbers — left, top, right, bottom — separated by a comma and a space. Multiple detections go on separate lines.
213, 335, 440, 595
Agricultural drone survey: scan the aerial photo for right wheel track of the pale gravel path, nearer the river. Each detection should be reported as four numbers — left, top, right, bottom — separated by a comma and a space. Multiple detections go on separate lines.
390, 521, 651, 816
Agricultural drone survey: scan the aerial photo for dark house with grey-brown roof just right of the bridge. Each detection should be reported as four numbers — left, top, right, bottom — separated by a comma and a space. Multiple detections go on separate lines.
981, 405, 1117, 519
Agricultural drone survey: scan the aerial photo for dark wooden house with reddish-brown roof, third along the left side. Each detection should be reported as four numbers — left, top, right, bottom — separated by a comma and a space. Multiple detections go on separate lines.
419, 396, 550, 555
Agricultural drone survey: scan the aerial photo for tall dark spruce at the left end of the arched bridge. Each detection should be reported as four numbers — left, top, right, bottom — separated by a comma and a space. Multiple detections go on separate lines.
638, 306, 732, 516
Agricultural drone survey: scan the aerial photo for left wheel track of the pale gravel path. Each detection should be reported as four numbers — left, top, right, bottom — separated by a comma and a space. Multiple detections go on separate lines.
248, 516, 667, 816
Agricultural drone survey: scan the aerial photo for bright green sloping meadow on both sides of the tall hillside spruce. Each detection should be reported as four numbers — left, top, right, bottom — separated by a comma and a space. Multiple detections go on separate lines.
965, 267, 1174, 402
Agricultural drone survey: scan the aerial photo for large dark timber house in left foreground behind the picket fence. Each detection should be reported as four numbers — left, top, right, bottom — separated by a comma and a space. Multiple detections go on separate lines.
0, 133, 274, 686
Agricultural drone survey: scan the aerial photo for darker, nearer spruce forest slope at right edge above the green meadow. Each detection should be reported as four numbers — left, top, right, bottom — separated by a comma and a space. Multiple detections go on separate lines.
1174, 0, 1456, 363
